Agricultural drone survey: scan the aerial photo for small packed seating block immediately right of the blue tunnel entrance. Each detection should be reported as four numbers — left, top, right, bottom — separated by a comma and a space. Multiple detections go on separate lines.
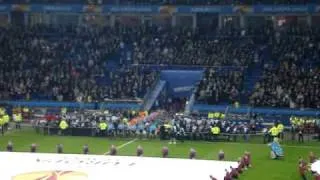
196, 68, 243, 104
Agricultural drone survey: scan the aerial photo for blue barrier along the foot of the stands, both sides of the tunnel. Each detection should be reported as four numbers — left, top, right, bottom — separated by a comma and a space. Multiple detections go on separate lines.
0, 100, 320, 117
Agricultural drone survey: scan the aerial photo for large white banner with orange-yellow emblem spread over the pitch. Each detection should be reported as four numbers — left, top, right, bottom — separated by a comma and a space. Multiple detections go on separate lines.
0, 152, 237, 180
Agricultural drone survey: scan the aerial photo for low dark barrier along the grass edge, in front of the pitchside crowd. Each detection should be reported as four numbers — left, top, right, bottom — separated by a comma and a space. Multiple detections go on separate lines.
34, 126, 320, 144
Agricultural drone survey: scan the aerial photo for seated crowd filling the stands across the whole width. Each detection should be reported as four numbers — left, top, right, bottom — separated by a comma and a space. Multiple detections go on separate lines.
0, 22, 320, 108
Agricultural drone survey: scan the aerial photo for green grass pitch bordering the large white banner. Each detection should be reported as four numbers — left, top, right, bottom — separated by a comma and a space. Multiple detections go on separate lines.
0, 128, 320, 180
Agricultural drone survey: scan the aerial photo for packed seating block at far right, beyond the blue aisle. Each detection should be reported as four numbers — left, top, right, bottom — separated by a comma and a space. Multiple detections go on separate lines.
249, 27, 320, 108
